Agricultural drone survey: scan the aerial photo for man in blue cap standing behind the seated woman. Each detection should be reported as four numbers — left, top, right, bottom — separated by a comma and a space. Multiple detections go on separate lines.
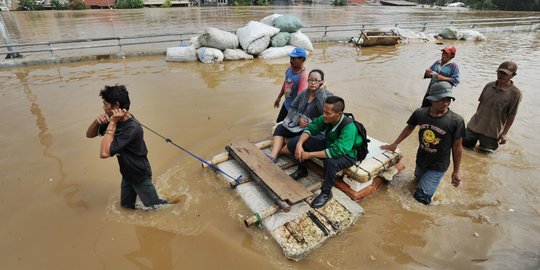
274, 48, 308, 123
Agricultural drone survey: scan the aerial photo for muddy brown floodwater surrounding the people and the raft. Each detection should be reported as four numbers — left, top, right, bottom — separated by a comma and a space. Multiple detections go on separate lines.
0, 4, 540, 269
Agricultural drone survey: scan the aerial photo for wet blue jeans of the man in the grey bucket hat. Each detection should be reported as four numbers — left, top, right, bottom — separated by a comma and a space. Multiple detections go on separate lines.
414, 166, 445, 204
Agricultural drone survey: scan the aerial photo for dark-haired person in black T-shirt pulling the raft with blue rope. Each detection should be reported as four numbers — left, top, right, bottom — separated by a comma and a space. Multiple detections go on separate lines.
86, 85, 168, 209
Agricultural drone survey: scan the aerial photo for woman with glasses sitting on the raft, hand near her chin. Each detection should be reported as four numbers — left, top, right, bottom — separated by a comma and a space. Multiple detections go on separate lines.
267, 69, 333, 163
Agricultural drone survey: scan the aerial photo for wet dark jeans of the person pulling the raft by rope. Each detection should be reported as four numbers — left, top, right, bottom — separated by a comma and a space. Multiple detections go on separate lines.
120, 178, 166, 209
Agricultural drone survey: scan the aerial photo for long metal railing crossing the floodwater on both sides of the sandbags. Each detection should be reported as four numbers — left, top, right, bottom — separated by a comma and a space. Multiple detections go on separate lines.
0, 16, 540, 61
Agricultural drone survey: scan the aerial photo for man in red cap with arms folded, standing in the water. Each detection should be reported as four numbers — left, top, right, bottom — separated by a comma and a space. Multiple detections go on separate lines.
422, 47, 460, 107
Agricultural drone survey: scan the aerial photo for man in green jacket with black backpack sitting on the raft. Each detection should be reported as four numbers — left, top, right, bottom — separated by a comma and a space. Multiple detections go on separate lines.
287, 96, 362, 208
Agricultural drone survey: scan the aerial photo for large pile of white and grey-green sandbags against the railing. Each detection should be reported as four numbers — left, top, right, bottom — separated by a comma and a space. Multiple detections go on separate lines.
165, 14, 313, 63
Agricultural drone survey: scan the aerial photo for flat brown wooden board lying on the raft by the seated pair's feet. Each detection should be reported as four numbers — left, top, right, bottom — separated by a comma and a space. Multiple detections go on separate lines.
227, 141, 313, 204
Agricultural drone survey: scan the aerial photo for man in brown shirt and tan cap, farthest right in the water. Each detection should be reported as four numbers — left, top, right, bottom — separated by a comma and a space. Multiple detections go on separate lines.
463, 61, 521, 152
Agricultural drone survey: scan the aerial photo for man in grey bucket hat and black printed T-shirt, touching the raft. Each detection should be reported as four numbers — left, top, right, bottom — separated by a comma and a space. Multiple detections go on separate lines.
381, 82, 465, 205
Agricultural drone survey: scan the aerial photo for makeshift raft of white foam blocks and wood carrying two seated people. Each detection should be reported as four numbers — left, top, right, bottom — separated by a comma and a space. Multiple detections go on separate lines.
212, 138, 401, 261
